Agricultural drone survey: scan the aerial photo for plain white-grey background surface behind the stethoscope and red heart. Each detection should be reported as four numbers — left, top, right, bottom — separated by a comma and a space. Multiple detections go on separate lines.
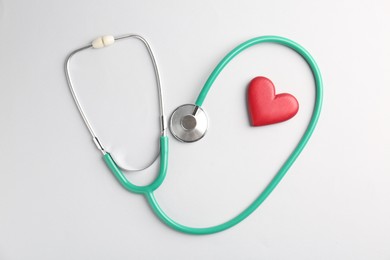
0, 0, 390, 260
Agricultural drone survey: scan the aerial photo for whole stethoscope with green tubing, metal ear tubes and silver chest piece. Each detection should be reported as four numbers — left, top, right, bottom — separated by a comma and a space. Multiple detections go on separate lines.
65, 34, 322, 235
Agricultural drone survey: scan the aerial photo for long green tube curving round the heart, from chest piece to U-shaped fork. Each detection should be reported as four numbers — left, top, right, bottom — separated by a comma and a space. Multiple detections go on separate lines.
145, 36, 323, 235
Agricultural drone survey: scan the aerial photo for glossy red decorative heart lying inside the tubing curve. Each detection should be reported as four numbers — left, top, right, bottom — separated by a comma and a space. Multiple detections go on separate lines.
248, 77, 299, 126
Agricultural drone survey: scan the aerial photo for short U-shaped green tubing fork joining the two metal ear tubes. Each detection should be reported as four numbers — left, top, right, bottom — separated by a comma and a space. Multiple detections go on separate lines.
103, 136, 168, 194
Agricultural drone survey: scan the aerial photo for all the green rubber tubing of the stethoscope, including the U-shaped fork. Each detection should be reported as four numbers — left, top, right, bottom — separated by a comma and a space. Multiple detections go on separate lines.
104, 36, 323, 235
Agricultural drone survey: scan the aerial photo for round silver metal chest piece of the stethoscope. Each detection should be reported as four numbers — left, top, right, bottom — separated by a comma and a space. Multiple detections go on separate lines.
169, 104, 208, 143
